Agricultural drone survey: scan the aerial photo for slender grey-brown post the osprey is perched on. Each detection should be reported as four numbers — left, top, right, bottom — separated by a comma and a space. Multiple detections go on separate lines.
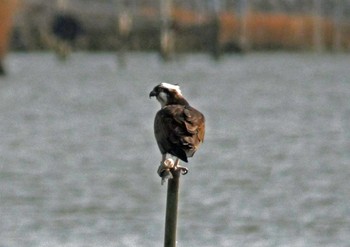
164, 170, 180, 247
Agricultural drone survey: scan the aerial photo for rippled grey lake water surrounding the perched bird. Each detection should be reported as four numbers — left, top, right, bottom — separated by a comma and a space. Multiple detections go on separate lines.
0, 53, 350, 247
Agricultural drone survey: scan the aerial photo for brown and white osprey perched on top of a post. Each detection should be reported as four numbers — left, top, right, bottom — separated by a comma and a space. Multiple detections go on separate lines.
149, 82, 205, 184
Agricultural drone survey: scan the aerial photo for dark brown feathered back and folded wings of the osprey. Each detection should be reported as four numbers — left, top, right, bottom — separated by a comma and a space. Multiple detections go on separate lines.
154, 105, 205, 162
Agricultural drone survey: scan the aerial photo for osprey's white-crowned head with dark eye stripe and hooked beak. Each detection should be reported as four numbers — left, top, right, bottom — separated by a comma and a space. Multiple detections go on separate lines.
149, 82, 188, 107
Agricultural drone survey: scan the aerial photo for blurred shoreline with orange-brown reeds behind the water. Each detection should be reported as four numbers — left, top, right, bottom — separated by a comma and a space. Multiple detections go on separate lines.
5, 0, 350, 52
